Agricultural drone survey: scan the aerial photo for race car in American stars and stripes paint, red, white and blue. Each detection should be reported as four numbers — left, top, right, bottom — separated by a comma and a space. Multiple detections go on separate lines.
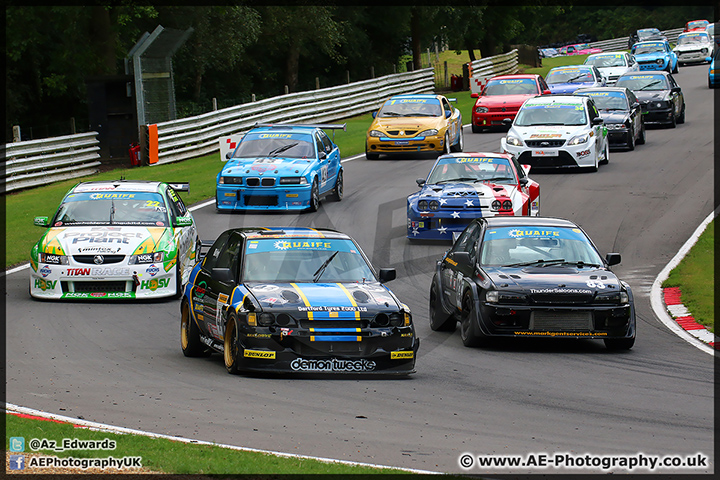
407, 152, 540, 240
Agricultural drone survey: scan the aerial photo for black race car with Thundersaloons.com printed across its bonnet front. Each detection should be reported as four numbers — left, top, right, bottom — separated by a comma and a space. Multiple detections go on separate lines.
429, 217, 635, 350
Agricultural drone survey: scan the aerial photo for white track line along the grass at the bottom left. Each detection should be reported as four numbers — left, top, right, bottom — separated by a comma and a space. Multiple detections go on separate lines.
5, 403, 442, 475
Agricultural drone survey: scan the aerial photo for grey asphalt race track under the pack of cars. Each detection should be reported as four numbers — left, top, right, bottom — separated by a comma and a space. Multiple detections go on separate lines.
6, 65, 714, 474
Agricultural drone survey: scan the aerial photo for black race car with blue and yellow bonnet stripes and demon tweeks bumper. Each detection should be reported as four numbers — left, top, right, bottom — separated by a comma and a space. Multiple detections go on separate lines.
180, 227, 419, 375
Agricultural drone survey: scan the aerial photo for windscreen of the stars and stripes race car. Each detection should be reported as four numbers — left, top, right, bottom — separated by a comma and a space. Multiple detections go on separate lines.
426, 157, 517, 184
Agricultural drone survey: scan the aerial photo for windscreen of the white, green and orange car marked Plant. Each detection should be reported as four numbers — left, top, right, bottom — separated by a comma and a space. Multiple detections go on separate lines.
53, 191, 168, 227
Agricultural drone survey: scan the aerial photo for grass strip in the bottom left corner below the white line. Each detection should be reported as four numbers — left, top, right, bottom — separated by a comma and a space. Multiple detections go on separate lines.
5, 414, 420, 478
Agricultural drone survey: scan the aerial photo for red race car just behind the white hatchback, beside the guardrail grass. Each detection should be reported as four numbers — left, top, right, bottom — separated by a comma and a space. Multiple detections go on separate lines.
470, 74, 550, 133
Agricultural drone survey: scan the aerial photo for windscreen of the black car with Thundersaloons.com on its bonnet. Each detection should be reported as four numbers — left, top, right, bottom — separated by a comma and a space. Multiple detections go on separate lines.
480, 226, 603, 266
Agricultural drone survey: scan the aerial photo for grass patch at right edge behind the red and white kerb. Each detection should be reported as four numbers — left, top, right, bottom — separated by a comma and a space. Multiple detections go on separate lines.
662, 220, 715, 333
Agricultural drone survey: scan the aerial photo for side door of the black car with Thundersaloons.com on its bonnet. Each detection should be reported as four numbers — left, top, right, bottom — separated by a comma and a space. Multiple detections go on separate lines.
440, 222, 480, 309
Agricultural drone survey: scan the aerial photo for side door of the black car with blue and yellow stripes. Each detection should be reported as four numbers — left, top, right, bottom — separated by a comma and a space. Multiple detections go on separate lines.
203, 232, 243, 340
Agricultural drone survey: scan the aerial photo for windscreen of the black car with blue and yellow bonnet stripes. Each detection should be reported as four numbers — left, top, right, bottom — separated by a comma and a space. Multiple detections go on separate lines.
242, 237, 375, 283
